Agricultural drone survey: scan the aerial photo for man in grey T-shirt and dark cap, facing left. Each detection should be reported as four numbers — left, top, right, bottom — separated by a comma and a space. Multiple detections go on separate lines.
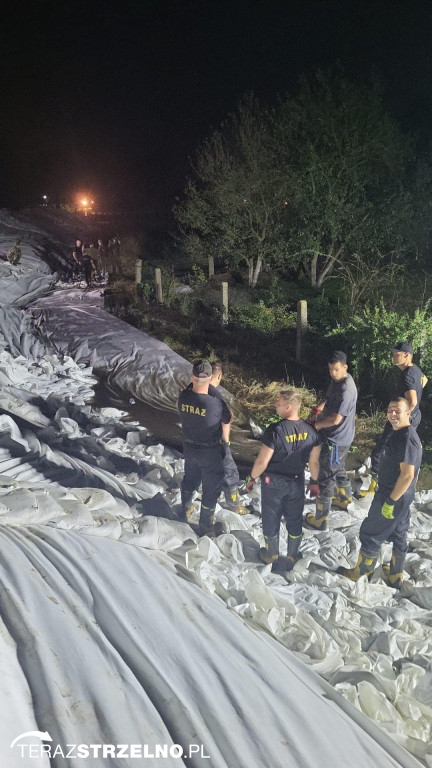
306, 350, 357, 531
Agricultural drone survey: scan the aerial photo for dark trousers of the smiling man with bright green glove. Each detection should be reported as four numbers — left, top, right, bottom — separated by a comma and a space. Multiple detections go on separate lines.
360, 485, 415, 555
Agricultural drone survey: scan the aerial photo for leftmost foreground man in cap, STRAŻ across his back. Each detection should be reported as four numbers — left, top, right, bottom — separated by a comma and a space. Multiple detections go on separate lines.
178, 361, 231, 535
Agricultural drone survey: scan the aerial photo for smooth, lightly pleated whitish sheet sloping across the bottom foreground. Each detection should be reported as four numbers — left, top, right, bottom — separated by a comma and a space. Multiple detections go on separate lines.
0, 526, 422, 768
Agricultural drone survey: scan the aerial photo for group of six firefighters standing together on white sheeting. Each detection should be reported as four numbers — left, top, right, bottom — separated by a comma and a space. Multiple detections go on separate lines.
178, 341, 427, 588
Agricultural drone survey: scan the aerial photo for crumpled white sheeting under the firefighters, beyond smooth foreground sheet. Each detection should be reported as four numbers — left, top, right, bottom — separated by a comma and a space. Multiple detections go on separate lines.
0, 356, 432, 765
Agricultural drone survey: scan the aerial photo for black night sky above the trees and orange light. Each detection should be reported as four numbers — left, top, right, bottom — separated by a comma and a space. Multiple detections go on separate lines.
0, 0, 432, 224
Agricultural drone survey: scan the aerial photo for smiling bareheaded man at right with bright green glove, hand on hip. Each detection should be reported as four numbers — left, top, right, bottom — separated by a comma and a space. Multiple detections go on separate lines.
338, 397, 422, 588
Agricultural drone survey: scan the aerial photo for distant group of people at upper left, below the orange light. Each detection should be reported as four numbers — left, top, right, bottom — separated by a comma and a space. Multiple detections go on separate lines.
66, 237, 122, 288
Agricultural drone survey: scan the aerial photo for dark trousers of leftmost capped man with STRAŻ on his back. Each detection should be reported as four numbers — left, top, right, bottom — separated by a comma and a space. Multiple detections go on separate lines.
181, 444, 224, 511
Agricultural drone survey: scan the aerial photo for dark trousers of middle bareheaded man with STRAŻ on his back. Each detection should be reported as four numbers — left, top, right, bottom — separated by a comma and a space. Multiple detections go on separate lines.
261, 472, 305, 537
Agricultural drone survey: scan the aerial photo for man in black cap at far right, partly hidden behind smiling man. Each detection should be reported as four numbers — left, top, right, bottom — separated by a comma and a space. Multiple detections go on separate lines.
360, 341, 428, 497
